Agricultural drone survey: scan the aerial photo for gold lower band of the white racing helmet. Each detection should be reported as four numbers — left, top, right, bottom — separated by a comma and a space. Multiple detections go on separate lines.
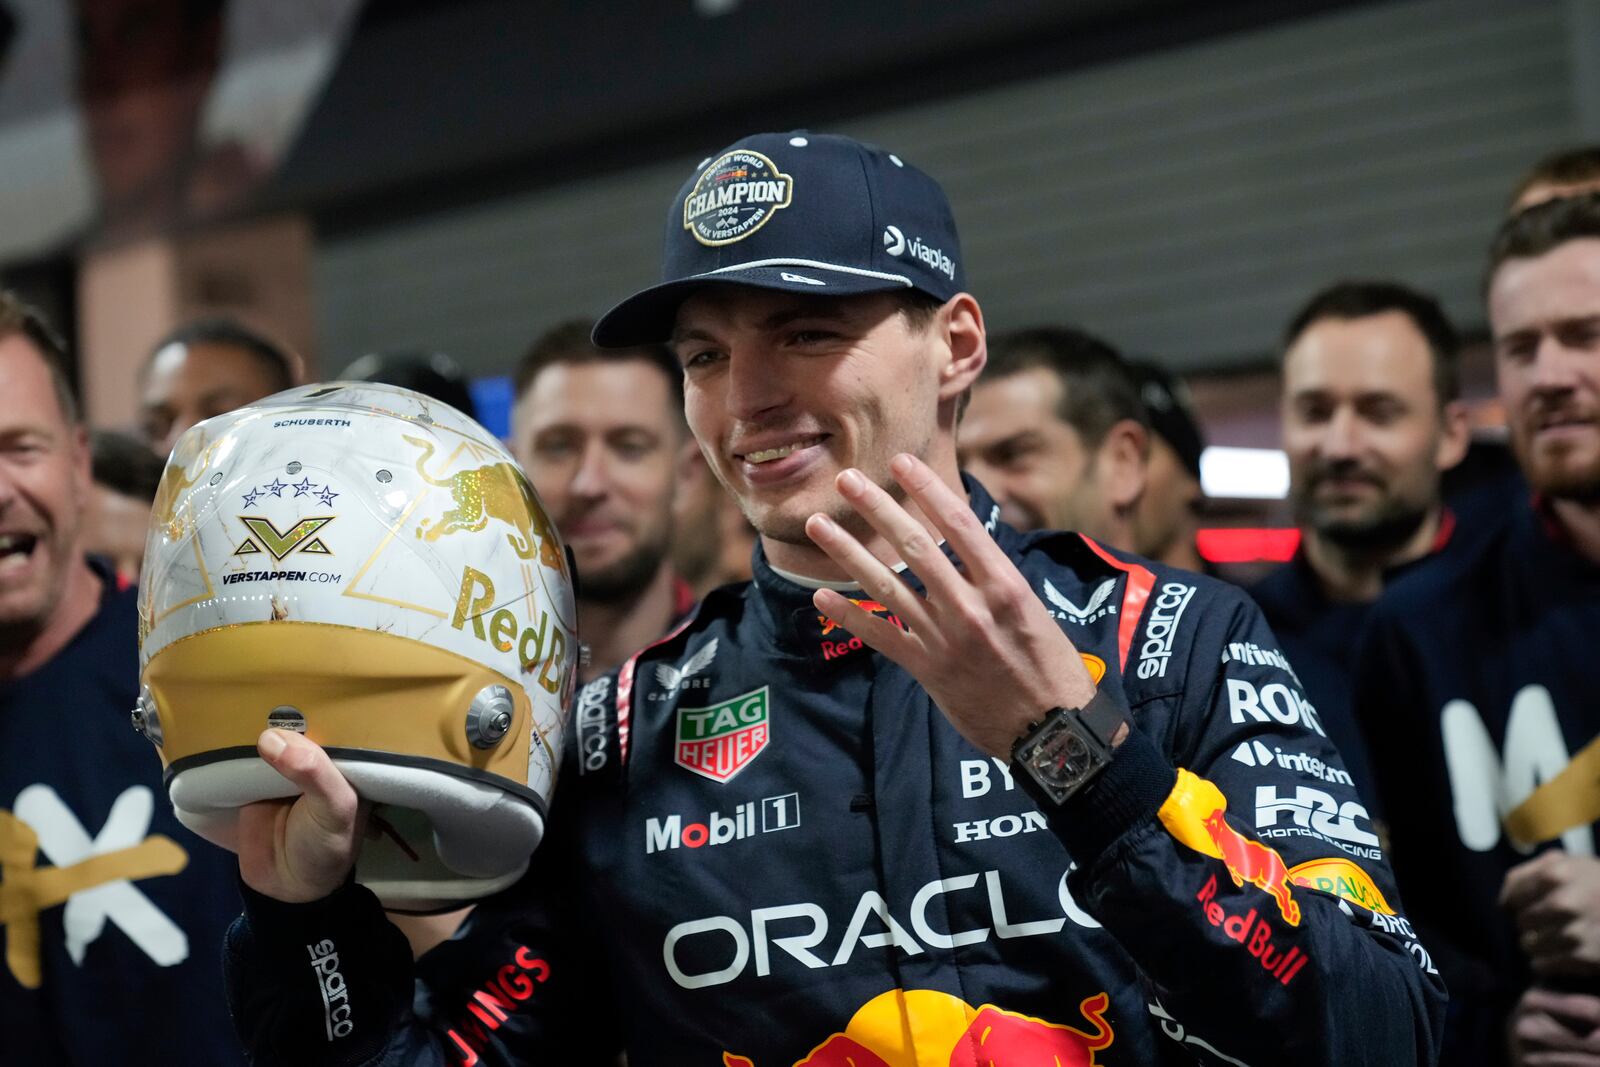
136, 621, 537, 793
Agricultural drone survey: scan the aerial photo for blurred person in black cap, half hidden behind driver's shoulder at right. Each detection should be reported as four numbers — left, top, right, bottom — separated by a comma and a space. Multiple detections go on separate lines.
1133, 363, 1206, 571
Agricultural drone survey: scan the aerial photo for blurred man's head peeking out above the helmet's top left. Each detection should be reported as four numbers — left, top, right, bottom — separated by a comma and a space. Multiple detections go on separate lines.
139, 317, 301, 456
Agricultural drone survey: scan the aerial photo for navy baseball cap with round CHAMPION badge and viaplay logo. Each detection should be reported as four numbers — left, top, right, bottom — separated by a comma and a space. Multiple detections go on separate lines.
594, 131, 966, 347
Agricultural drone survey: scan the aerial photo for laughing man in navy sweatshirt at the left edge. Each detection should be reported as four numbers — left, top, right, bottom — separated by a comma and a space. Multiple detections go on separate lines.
0, 293, 243, 1064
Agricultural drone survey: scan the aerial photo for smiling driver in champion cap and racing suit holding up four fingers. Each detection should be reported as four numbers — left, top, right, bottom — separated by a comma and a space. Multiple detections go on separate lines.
227, 131, 1443, 1067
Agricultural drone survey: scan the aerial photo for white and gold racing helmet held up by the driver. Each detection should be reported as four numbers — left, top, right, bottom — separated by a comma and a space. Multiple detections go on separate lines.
134, 382, 578, 910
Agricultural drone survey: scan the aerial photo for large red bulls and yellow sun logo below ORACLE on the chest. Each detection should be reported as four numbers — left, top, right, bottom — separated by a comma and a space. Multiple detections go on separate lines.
722, 989, 1115, 1067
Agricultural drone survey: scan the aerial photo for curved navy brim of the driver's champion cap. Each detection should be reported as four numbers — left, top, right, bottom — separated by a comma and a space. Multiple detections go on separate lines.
592, 261, 915, 349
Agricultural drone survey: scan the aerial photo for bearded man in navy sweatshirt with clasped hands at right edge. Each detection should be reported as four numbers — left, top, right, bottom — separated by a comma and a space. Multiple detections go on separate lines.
1357, 195, 1600, 1064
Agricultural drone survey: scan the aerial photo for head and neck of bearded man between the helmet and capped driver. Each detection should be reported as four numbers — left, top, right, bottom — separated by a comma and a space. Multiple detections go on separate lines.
510, 320, 694, 681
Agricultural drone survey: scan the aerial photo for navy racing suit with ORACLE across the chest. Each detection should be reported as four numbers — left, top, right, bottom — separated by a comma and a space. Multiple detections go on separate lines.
227, 480, 1445, 1067
